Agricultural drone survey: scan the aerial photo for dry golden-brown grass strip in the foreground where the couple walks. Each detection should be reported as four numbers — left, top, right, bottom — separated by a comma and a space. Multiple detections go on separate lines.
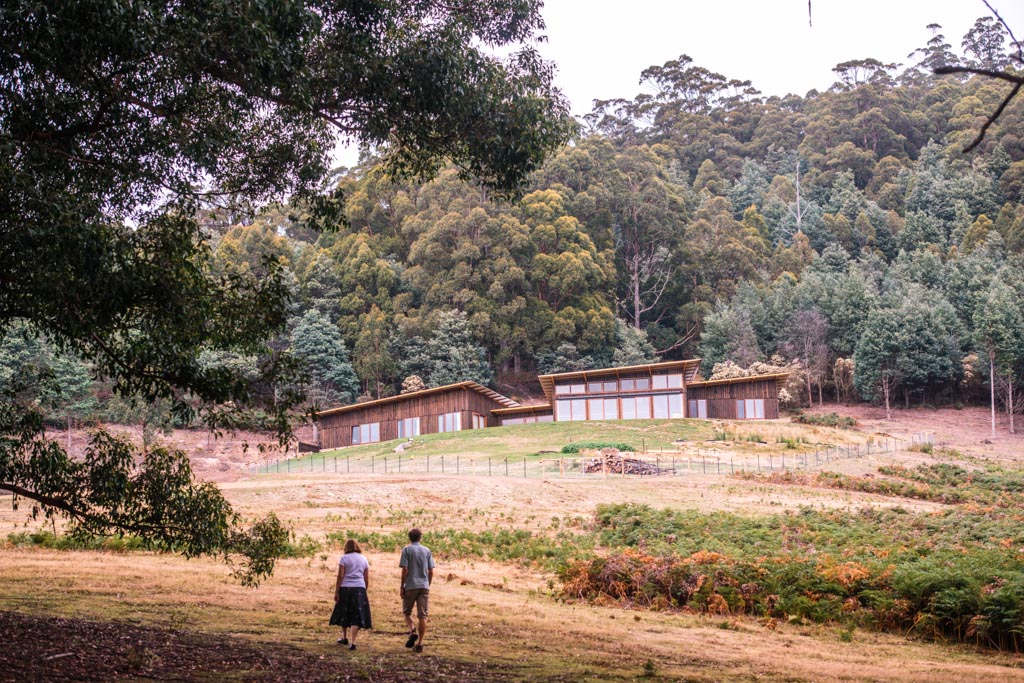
0, 536, 1024, 682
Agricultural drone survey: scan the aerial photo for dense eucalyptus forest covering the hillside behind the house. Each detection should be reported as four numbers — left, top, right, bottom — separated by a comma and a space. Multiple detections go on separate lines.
6, 17, 1024, 426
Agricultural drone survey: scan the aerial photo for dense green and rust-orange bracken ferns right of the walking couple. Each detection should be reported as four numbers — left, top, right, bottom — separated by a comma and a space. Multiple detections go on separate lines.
559, 464, 1024, 651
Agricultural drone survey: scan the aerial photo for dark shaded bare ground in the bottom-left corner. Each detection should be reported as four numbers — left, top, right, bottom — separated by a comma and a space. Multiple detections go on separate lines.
0, 611, 512, 683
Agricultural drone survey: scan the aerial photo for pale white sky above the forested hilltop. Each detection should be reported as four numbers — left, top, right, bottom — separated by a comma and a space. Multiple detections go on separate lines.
539, 0, 1024, 116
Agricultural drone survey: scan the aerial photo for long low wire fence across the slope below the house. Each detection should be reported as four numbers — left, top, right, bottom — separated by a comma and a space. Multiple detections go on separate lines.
250, 432, 933, 479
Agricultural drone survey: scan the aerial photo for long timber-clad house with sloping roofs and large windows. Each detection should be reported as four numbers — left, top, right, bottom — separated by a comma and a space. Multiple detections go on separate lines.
318, 358, 786, 449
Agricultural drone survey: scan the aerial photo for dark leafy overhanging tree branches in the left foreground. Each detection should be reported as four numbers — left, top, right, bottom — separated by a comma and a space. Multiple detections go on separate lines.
0, 0, 574, 581
